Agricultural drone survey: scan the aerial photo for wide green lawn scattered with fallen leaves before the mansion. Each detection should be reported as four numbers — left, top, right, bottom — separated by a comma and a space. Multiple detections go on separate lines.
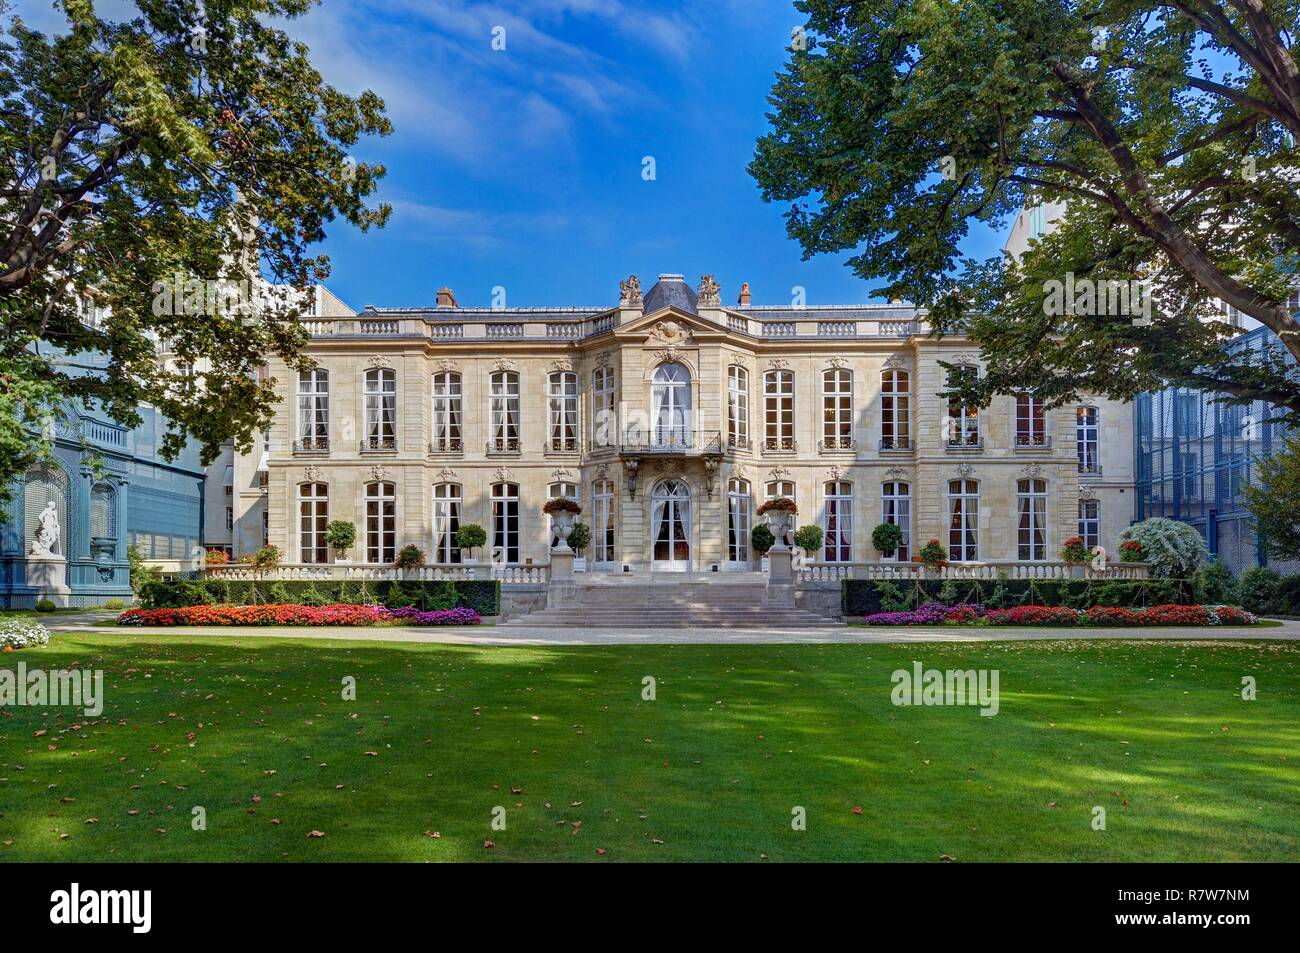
0, 632, 1300, 862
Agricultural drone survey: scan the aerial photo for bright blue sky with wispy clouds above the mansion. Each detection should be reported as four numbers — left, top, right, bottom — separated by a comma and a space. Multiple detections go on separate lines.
17, 0, 1001, 308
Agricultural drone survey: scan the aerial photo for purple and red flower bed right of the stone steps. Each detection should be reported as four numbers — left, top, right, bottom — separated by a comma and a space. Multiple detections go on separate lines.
863, 602, 1258, 627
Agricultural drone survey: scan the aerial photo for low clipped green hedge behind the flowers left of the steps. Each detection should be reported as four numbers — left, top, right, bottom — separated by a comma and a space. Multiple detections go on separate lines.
139, 579, 501, 616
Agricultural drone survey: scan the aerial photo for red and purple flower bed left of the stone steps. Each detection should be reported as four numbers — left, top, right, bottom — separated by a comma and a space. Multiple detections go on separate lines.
117, 603, 482, 625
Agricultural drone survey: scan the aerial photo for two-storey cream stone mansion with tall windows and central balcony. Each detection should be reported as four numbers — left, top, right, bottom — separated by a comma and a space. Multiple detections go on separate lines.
228, 274, 1134, 573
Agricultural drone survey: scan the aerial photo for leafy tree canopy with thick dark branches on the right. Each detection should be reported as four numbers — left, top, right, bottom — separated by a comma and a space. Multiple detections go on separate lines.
750, 0, 1300, 420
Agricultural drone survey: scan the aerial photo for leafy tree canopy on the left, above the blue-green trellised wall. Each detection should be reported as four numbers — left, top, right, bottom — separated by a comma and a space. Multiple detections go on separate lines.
0, 0, 391, 494
